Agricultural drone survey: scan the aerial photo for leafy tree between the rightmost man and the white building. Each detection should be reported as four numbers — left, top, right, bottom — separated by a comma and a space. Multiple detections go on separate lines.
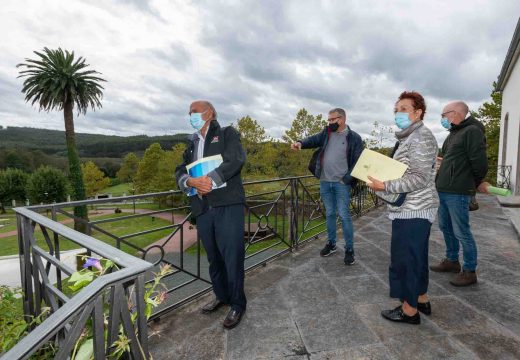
471, 82, 502, 183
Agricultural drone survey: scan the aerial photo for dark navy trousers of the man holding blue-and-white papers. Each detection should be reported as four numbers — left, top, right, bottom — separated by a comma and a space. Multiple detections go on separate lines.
197, 204, 247, 310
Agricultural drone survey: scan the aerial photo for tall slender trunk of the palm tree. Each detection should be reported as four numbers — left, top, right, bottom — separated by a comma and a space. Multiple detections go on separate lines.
63, 101, 88, 234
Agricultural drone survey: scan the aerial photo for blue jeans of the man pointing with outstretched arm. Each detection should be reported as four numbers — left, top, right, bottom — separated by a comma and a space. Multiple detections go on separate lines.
320, 181, 354, 250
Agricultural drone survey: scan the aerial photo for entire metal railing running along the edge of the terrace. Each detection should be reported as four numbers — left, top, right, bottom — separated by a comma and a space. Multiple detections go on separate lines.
2, 176, 379, 359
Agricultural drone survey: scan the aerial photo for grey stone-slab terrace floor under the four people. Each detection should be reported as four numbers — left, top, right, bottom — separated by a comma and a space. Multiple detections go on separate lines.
150, 196, 520, 360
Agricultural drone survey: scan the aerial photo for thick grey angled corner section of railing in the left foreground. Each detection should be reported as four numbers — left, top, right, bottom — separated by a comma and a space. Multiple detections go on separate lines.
5, 208, 152, 359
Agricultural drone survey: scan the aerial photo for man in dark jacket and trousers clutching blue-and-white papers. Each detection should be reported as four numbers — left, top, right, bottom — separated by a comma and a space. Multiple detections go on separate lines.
175, 101, 246, 329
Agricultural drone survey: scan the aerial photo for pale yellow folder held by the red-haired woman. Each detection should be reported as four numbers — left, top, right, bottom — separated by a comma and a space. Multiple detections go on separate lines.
351, 149, 408, 182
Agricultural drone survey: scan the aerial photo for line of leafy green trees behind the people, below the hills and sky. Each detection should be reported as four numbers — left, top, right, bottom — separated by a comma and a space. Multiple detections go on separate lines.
0, 91, 501, 214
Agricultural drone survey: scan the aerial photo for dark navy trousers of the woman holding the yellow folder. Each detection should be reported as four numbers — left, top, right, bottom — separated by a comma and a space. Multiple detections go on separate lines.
389, 219, 432, 308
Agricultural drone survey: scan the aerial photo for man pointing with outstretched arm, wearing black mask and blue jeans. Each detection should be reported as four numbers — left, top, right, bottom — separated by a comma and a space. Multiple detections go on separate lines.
291, 108, 363, 265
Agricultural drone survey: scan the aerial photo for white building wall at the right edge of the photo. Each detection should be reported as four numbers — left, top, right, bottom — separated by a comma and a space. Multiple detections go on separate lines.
498, 60, 520, 195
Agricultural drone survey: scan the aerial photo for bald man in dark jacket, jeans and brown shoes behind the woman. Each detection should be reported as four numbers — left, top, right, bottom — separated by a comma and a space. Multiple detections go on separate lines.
430, 101, 489, 286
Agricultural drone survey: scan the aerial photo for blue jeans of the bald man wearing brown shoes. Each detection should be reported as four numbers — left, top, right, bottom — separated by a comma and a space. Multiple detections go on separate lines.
439, 192, 477, 271
